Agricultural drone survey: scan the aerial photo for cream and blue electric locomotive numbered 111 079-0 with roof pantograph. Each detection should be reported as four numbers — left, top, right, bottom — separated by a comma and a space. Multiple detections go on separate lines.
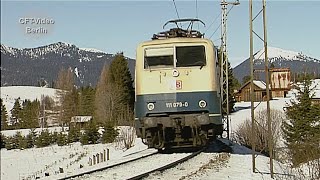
135, 19, 223, 149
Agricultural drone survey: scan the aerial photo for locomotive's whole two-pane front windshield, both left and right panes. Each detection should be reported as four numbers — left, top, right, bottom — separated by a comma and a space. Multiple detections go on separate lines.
144, 46, 206, 69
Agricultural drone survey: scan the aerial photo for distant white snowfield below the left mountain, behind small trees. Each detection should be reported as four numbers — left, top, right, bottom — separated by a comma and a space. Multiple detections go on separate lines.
0, 86, 57, 116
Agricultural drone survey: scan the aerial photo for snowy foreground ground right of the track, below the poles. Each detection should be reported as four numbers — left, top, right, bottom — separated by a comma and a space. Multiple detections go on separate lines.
147, 141, 289, 180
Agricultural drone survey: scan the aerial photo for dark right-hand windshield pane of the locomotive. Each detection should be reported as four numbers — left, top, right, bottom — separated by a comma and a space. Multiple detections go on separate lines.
176, 46, 206, 67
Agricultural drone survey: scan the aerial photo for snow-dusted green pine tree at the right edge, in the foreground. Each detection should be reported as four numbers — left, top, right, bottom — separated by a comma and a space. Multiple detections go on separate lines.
282, 76, 320, 165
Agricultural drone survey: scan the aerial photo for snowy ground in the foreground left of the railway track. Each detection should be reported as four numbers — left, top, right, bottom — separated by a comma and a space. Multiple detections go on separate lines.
1, 139, 150, 180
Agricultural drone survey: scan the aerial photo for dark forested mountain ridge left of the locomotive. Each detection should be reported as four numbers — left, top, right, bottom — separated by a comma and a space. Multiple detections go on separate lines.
1, 42, 135, 86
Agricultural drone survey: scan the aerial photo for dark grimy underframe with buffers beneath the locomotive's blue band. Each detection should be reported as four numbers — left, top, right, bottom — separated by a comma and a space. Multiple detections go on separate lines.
138, 113, 223, 149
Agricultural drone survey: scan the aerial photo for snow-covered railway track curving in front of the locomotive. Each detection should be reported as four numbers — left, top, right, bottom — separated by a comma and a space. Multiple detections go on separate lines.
61, 140, 231, 180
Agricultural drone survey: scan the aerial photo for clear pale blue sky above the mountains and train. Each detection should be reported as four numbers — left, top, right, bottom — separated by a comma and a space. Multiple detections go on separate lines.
1, 0, 320, 67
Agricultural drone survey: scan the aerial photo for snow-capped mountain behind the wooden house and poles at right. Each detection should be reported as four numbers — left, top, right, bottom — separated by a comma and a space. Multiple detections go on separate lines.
233, 47, 320, 83
